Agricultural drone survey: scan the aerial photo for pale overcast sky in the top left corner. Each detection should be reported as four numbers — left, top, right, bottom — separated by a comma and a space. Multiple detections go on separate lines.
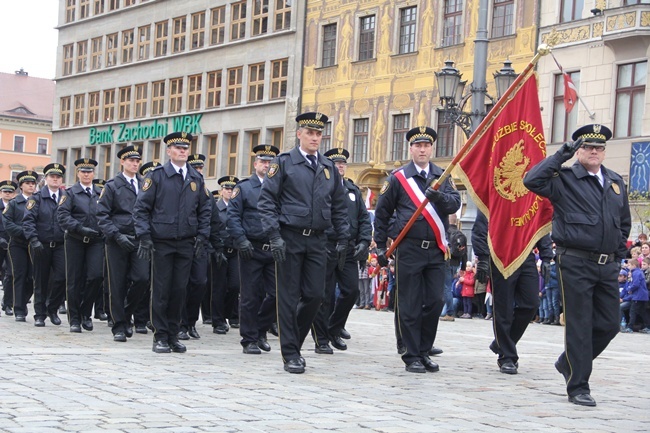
0, 0, 59, 78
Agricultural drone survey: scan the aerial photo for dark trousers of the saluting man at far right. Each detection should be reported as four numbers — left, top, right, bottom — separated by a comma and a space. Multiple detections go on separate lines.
556, 255, 620, 397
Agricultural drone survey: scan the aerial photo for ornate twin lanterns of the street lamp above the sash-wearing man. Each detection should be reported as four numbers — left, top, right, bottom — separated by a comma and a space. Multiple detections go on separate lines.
435, 60, 517, 137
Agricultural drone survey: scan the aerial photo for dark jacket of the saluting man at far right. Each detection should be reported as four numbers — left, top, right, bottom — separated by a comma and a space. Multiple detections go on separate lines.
524, 154, 632, 260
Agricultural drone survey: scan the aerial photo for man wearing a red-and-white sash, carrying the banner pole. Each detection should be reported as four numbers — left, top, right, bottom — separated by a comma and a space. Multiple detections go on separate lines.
375, 126, 460, 373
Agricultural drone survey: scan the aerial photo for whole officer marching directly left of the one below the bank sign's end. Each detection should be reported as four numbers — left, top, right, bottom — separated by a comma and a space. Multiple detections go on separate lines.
97, 145, 150, 342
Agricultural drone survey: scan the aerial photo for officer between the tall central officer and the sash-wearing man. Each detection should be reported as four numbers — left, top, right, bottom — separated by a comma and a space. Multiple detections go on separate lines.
312, 148, 372, 354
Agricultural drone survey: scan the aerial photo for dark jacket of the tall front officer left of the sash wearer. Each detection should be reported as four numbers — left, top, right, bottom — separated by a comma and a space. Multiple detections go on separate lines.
257, 147, 350, 241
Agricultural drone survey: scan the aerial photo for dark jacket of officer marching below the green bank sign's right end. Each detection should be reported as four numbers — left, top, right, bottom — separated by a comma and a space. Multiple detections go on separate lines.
134, 161, 213, 241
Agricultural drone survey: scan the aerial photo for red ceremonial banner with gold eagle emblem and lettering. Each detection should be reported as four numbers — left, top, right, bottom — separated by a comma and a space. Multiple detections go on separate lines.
456, 74, 553, 278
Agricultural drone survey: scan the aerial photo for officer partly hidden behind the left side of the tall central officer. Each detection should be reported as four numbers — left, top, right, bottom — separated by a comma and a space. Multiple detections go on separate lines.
227, 144, 280, 355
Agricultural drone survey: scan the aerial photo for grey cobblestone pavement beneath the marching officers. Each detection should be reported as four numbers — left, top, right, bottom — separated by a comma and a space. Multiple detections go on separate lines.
0, 296, 650, 433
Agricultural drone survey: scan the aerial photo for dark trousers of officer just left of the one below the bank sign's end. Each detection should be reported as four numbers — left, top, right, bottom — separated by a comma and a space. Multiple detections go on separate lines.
104, 239, 150, 334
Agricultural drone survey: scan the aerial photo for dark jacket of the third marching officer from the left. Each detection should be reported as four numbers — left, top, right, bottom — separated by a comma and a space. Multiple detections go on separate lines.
23, 187, 63, 243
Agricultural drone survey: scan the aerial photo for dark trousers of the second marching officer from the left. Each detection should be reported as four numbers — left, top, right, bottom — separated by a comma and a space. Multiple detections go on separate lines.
5, 238, 34, 316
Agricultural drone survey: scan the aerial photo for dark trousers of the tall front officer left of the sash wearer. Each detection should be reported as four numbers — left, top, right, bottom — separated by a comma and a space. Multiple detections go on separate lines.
276, 227, 327, 362
